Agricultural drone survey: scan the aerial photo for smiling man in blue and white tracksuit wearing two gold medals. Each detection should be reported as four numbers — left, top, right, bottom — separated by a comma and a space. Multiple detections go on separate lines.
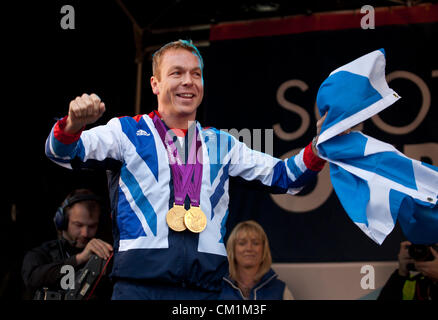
46, 40, 324, 299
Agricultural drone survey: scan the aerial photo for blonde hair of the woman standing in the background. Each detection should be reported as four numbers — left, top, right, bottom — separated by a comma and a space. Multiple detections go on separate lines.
227, 220, 272, 282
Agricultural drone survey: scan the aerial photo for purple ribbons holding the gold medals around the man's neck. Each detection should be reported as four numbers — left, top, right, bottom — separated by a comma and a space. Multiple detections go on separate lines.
152, 112, 202, 207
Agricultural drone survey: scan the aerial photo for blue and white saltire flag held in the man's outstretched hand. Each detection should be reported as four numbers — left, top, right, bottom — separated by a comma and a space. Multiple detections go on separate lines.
317, 49, 438, 244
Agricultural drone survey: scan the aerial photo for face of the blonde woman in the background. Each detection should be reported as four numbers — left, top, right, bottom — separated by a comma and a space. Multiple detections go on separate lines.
234, 231, 263, 268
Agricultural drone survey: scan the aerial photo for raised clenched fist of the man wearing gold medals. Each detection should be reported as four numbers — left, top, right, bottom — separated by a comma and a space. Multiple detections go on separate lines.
64, 93, 105, 133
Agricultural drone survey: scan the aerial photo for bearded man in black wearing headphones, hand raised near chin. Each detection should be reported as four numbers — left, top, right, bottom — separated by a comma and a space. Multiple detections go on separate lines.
21, 189, 113, 299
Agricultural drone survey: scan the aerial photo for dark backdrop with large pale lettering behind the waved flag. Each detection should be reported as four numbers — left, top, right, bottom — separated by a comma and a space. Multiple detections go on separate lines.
203, 5, 438, 262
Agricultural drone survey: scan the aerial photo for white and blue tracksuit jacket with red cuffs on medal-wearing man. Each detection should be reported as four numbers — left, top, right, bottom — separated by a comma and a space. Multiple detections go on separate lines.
46, 114, 323, 290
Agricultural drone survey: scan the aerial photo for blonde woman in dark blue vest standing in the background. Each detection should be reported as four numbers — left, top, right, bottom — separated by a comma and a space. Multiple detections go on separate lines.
220, 220, 293, 300
